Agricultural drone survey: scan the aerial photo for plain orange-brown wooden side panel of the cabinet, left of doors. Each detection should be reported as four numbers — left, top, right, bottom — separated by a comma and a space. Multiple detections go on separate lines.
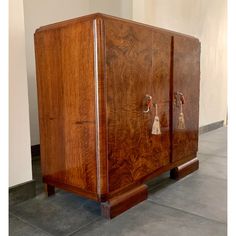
35, 20, 97, 192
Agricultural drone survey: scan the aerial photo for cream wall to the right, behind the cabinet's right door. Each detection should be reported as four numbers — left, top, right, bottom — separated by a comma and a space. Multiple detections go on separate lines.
133, 0, 227, 126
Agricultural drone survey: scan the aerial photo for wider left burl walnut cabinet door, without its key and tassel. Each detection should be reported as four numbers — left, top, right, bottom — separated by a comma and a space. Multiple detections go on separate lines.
104, 19, 171, 191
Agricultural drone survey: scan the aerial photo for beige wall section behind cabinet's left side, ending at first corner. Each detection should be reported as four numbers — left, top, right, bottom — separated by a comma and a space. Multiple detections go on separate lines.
24, 0, 89, 145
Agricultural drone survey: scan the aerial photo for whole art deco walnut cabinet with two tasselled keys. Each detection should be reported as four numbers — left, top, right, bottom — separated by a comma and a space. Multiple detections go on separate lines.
35, 13, 200, 218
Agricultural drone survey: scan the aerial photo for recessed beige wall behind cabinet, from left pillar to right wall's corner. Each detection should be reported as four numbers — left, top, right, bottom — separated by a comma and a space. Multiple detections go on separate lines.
24, 0, 132, 145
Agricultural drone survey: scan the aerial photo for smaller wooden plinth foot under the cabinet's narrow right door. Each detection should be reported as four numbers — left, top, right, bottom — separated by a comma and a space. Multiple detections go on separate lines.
170, 158, 199, 180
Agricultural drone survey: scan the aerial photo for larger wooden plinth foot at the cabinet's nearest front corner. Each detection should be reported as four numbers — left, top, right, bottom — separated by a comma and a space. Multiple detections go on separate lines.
101, 184, 148, 219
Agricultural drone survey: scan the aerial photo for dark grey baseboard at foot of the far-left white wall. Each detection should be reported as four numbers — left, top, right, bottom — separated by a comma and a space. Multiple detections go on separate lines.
9, 180, 36, 206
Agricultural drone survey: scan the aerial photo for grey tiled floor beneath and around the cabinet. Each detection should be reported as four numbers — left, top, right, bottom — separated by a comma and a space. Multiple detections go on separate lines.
9, 128, 227, 236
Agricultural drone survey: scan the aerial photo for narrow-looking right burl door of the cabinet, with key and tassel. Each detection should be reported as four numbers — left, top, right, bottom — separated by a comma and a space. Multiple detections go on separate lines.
171, 36, 200, 162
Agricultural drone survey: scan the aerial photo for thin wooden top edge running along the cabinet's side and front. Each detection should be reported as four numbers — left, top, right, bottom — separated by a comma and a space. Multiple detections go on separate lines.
35, 13, 198, 40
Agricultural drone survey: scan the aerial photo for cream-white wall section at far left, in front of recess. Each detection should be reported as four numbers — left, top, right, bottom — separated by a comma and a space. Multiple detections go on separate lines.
9, 0, 32, 187
